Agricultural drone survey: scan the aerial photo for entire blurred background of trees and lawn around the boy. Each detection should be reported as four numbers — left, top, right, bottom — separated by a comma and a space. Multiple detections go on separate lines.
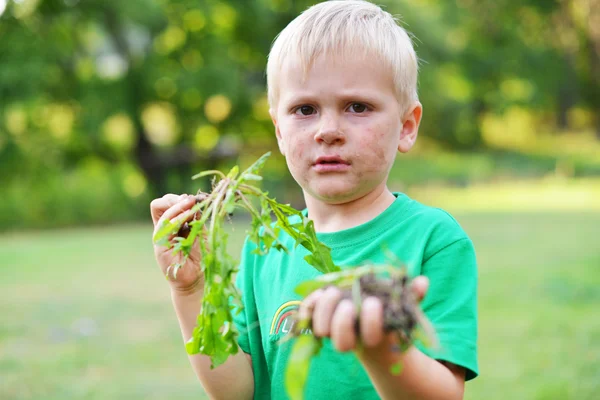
0, 0, 600, 400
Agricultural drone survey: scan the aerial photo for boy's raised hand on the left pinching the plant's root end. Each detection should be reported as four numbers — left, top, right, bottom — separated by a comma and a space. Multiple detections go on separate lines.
150, 194, 203, 293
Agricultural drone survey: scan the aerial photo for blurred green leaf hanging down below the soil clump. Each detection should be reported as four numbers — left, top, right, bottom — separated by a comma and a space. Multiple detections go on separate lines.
285, 335, 323, 400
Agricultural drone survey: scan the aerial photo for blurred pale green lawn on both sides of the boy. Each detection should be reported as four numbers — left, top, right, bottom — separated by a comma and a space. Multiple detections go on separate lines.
0, 213, 600, 400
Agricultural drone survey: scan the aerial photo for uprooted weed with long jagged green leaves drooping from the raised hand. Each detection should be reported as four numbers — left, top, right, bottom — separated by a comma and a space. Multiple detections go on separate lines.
153, 153, 340, 367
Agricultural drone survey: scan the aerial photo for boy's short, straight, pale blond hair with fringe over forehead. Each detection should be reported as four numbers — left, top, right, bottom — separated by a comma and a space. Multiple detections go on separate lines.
267, 0, 418, 112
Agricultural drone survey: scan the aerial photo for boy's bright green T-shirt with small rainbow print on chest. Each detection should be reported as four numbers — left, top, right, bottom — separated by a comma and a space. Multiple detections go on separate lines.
235, 193, 478, 400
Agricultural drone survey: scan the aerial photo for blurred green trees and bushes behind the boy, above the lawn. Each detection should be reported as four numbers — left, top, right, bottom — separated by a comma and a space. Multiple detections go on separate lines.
0, 0, 600, 230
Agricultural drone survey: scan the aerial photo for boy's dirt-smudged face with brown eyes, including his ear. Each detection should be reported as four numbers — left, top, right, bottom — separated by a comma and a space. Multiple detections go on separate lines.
271, 56, 421, 204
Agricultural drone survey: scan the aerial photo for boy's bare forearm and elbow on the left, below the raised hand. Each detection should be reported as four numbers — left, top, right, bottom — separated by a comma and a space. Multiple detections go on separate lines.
171, 291, 254, 400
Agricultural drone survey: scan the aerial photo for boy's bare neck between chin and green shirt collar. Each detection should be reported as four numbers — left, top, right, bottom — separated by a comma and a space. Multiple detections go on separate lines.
304, 185, 396, 233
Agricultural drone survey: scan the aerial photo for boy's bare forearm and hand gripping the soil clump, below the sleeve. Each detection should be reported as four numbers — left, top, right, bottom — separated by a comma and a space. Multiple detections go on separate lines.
308, 277, 466, 400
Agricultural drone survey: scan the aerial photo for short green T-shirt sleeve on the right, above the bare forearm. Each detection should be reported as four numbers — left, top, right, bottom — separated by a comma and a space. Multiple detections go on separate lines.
420, 237, 479, 380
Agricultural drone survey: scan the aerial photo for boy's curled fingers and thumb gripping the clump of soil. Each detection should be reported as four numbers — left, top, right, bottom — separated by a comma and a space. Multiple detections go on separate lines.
299, 276, 429, 352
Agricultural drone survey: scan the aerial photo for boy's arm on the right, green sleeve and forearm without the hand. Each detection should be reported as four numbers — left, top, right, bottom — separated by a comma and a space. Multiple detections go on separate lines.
358, 237, 478, 399
